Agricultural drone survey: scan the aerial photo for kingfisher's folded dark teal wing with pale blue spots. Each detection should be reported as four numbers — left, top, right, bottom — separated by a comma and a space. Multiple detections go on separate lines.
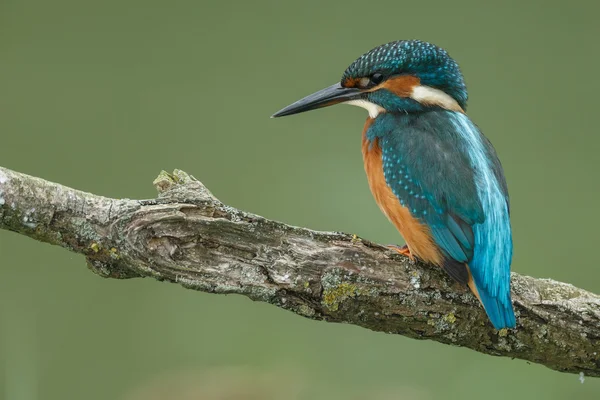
379, 112, 485, 263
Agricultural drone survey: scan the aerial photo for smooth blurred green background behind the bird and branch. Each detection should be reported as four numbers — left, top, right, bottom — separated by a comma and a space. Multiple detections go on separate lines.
0, 0, 600, 400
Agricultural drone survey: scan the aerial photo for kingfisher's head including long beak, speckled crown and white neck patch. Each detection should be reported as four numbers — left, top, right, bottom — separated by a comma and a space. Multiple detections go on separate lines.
273, 40, 467, 118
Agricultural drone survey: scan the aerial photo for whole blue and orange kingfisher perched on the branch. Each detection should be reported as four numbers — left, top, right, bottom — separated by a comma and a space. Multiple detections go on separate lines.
272, 40, 516, 330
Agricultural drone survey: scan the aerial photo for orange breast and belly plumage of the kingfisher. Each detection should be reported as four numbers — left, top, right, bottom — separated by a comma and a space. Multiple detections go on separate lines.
362, 118, 443, 265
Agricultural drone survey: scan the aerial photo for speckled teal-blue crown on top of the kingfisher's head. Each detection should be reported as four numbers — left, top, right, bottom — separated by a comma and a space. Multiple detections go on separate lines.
342, 40, 468, 109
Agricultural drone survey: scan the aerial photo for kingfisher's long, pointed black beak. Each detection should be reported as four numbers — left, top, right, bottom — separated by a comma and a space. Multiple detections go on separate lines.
271, 83, 361, 118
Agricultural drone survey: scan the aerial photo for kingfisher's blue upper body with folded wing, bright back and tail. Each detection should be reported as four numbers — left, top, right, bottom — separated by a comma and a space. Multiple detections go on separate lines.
367, 110, 515, 329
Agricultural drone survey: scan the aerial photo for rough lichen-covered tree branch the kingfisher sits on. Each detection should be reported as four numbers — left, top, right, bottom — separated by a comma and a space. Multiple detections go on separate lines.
0, 167, 600, 376
